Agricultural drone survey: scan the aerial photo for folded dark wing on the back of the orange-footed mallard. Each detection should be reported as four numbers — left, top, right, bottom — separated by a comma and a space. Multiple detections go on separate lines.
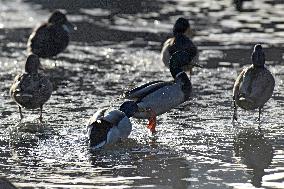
124, 81, 173, 101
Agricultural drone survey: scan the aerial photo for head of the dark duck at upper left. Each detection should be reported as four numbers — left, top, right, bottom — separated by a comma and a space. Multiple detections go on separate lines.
48, 10, 77, 33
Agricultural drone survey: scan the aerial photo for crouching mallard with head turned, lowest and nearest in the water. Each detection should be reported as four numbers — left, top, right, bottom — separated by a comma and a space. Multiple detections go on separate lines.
88, 101, 138, 149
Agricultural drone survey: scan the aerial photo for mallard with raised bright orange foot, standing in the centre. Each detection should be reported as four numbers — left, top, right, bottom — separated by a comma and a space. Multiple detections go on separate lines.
124, 51, 198, 133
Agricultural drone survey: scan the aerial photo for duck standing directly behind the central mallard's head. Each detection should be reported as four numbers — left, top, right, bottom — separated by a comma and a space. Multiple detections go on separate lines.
161, 18, 198, 76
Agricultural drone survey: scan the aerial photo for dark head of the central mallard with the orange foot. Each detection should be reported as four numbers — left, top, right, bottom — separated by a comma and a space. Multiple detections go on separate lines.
169, 51, 202, 78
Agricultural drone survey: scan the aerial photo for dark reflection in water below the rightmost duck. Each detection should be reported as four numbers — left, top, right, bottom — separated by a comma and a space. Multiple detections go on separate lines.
234, 129, 273, 188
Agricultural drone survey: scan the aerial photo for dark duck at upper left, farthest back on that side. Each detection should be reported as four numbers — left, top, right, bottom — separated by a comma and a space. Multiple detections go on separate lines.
27, 10, 76, 58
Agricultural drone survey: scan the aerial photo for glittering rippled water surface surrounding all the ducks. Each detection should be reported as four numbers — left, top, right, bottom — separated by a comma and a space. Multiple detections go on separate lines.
0, 0, 284, 189
